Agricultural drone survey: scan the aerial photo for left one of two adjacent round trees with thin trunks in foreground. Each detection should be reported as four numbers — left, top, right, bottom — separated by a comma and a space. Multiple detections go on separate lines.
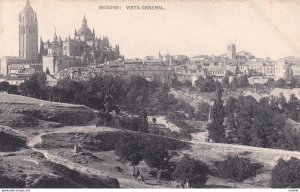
115, 134, 143, 175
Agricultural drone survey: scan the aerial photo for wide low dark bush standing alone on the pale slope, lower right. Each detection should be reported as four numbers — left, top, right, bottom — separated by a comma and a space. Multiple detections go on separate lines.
215, 155, 261, 182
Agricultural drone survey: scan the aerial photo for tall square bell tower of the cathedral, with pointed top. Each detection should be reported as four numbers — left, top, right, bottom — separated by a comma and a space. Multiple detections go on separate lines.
19, 0, 38, 63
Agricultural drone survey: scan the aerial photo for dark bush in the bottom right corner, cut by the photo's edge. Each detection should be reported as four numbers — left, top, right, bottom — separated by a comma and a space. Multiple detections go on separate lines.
271, 157, 300, 188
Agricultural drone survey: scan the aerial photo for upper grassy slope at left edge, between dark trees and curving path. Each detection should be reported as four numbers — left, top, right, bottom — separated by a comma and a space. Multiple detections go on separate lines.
0, 93, 97, 128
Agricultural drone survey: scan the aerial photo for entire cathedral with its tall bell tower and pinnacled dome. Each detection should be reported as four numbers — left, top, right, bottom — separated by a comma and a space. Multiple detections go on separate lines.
0, 0, 120, 78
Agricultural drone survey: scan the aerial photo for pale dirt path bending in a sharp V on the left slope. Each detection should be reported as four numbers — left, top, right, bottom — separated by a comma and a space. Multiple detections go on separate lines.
28, 126, 162, 188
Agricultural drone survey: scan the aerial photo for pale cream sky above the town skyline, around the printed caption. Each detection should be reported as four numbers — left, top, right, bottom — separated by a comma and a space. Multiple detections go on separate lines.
0, 0, 300, 59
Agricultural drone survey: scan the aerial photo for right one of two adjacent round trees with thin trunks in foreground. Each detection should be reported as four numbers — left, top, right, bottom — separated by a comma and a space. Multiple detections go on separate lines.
143, 143, 171, 181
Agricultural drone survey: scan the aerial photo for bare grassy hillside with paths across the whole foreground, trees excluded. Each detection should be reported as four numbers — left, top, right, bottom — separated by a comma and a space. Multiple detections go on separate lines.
0, 93, 300, 188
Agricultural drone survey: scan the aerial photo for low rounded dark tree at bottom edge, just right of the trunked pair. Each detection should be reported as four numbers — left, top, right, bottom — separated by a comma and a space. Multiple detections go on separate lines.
172, 155, 209, 187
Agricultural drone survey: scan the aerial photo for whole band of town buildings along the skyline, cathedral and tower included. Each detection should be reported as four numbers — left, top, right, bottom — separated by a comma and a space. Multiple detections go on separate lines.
0, 0, 300, 85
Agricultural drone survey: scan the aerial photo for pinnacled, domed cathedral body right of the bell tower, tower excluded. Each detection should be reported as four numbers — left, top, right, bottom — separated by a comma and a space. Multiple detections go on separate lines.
40, 16, 120, 75
